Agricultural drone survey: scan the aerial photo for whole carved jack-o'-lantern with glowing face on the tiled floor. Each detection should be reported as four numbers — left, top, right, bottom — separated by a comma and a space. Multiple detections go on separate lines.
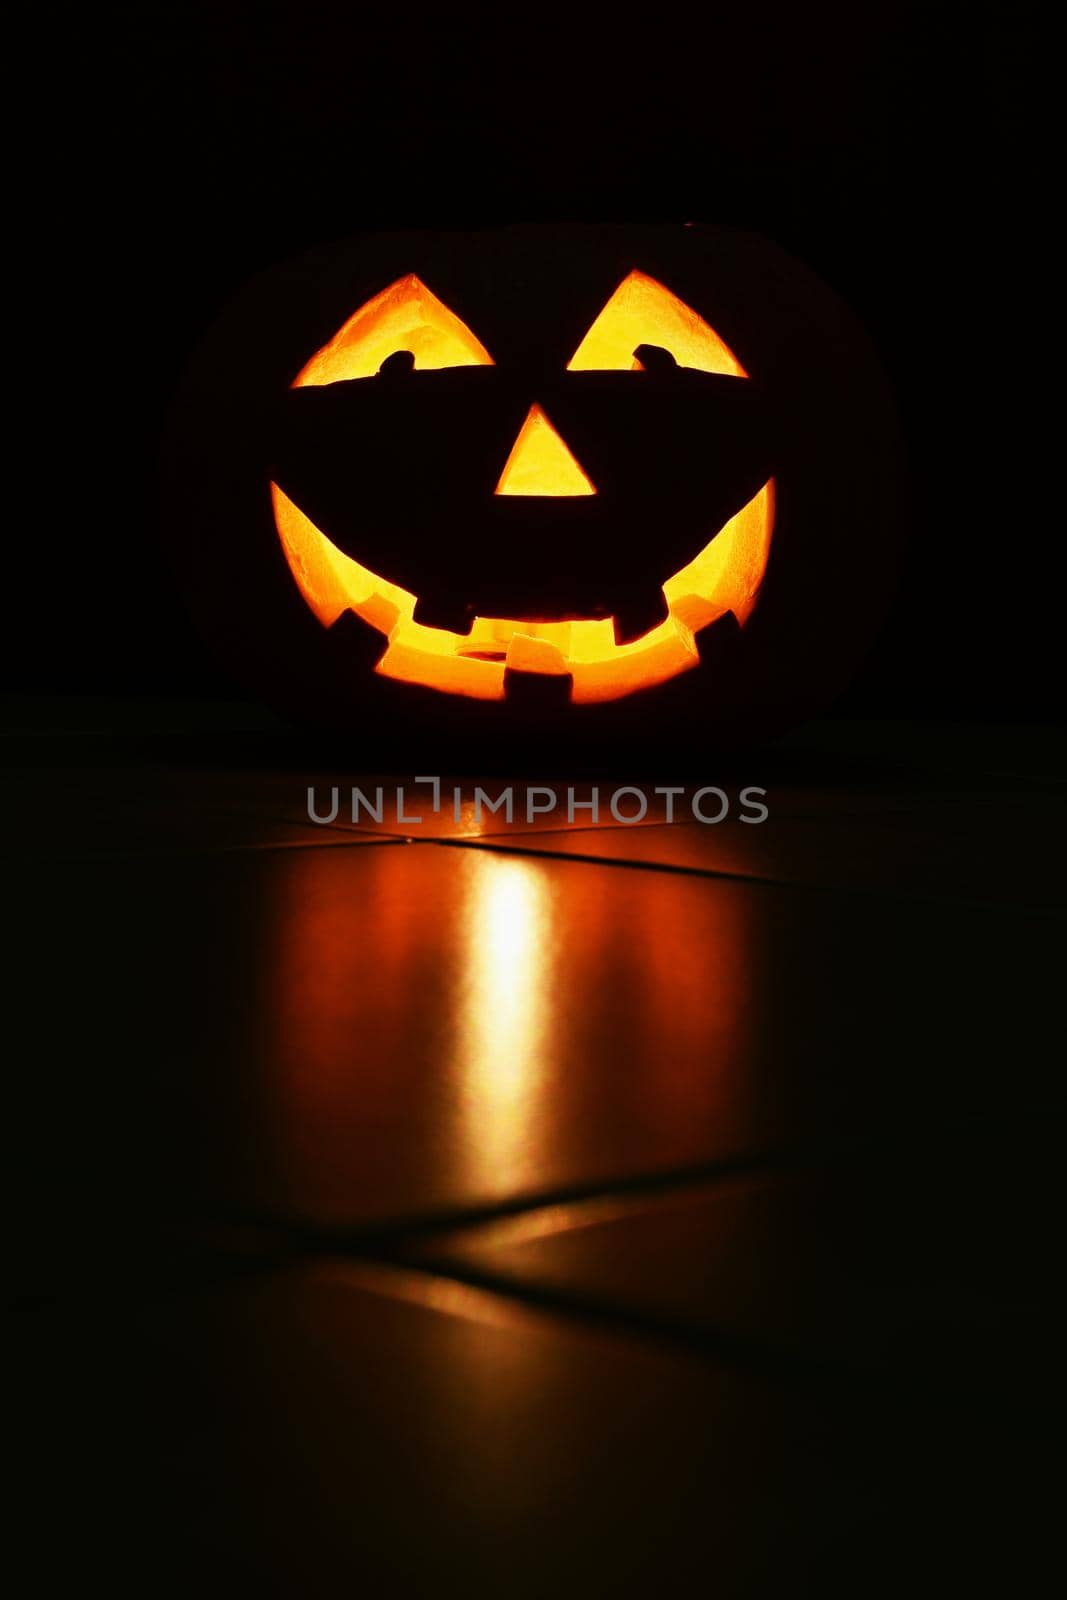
174, 227, 897, 758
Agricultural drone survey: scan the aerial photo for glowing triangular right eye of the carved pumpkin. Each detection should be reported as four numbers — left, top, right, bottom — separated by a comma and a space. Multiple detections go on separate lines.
566, 272, 749, 378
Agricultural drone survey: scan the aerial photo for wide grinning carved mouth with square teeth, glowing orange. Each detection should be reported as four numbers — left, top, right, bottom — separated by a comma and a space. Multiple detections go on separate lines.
270, 478, 774, 704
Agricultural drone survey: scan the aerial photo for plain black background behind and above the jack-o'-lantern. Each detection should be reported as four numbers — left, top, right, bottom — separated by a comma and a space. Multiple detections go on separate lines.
12, 5, 1061, 720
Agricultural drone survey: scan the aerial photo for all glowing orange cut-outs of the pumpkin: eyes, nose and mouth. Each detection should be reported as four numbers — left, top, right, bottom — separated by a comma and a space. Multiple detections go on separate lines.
270, 272, 774, 704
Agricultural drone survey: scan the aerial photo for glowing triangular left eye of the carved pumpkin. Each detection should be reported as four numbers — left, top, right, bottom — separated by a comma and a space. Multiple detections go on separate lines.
293, 272, 493, 389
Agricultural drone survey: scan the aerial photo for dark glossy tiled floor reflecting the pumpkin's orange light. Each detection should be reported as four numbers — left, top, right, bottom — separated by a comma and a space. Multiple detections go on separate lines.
2, 704, 1064, 1600
